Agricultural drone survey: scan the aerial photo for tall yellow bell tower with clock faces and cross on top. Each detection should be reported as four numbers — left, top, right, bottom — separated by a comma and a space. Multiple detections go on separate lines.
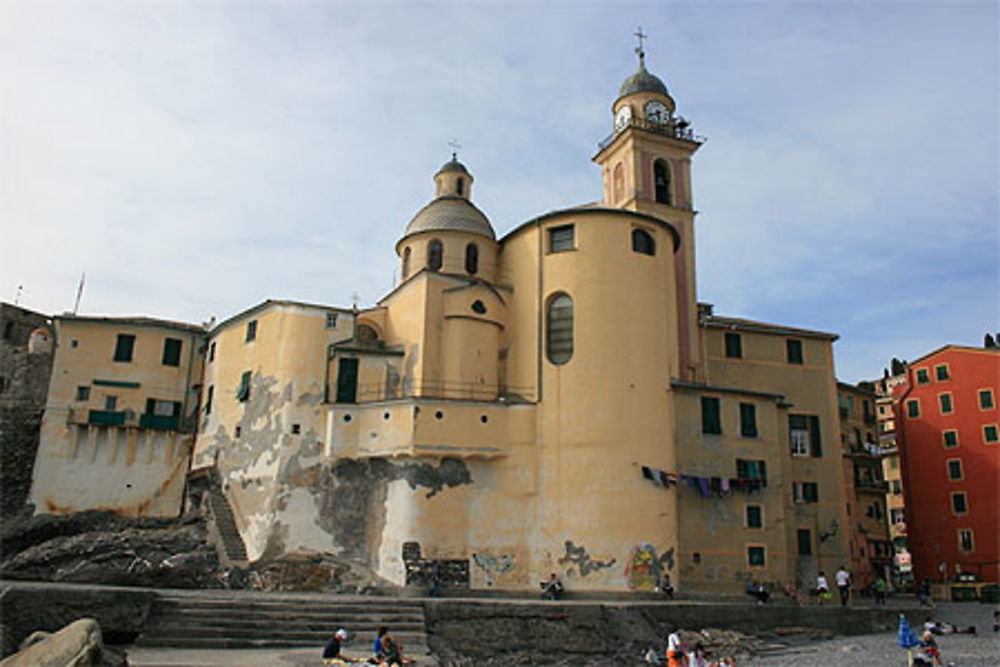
593, 28, 703, 381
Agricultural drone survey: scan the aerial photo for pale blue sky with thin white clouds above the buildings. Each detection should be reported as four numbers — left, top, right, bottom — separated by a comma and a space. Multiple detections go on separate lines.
0, 0, 1000, 382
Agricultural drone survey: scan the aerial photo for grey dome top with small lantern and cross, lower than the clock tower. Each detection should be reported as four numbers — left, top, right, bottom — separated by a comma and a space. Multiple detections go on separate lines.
403, 155, 496, 241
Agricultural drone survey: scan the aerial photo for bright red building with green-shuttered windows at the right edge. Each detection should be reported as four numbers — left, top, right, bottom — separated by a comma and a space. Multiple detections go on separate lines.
893, 345, 1000, 582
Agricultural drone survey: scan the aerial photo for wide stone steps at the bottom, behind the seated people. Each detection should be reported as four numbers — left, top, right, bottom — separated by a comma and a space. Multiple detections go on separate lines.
136, 591, 429, 664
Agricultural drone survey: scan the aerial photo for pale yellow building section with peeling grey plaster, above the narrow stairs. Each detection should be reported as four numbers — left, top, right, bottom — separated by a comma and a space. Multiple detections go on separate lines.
195, 302, 353, 560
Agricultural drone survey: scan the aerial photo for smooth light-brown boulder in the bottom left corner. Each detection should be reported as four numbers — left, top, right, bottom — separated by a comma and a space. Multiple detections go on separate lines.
0, 618, 127, 667
